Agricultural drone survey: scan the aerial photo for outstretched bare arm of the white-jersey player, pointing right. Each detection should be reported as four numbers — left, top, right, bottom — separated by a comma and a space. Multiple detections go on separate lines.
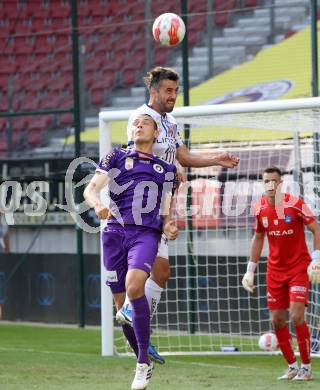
177, 145, 240, 168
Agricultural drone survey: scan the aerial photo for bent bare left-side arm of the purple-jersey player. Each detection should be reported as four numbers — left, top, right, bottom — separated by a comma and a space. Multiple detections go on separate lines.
83, 172, 110, 219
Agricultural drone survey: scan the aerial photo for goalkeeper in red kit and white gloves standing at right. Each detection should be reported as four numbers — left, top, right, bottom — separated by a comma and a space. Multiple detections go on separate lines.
242, 167, 320, 381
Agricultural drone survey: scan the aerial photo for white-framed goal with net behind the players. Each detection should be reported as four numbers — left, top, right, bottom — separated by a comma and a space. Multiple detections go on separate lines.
100, 98, 320, 355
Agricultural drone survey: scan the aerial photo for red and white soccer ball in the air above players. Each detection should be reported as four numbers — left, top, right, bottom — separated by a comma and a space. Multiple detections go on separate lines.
152, 13, 186, 46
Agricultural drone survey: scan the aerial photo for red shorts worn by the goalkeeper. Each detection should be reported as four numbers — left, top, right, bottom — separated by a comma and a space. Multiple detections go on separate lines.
267, 271, 309, 310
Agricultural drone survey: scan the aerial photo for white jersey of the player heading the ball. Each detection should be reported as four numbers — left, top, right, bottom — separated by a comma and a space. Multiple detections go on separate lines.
127, 104, 183, 164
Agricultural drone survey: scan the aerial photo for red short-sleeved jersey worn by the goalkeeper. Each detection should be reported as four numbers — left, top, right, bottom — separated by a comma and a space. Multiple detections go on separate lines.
255, 194, 315, 277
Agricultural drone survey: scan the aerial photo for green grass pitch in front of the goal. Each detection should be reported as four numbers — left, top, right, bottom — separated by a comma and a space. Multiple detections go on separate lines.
0, 323, 320, 390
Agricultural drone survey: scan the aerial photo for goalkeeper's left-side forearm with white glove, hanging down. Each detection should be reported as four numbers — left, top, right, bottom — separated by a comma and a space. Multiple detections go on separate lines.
242, 232, 264, 293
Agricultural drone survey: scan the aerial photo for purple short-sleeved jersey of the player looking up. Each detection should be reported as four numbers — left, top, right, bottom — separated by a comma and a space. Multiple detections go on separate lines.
97, 149, 176, 230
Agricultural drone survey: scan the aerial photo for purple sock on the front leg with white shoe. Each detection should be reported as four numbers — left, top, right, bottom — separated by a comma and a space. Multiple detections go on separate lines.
131, 295, 150, 364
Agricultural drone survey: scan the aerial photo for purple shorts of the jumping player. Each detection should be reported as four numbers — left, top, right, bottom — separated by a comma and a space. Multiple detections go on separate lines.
102, 224, 161, 294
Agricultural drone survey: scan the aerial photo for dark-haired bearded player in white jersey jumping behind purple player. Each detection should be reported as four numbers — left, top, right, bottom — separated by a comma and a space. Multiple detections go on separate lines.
116, 66, 239, 364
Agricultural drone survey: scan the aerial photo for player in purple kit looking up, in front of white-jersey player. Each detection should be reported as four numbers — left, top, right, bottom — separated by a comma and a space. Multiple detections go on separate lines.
84, 115, 178, 390
